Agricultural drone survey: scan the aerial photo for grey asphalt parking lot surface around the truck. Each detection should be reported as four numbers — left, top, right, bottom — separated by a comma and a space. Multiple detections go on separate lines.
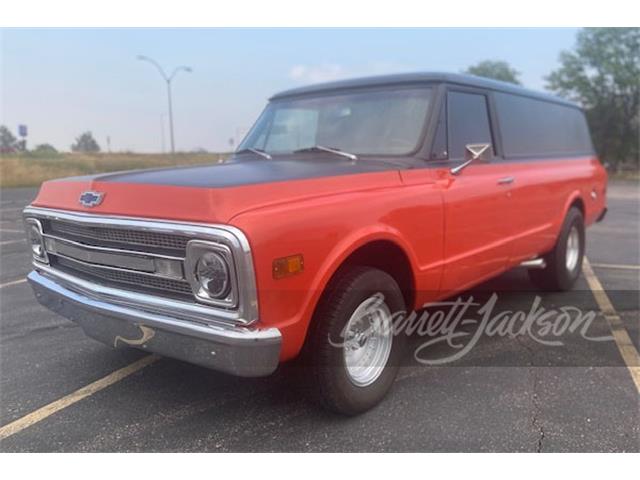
0, 182, 640, 452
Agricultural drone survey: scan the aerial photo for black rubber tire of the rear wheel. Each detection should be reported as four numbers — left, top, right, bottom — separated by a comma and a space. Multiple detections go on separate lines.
529, 207, 585, 292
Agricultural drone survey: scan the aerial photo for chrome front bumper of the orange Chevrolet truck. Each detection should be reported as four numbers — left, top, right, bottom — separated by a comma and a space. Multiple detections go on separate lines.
27, 271, 282, 377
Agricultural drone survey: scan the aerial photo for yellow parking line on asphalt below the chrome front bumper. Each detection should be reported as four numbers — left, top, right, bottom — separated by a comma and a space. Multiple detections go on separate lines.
0, 355, 160, 440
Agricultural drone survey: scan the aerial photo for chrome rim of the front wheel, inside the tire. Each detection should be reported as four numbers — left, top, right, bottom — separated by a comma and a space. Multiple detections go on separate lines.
343, 295, 393, 387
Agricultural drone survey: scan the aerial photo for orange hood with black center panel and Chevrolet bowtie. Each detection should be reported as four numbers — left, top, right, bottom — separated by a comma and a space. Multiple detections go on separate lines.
32, 160, 400, 223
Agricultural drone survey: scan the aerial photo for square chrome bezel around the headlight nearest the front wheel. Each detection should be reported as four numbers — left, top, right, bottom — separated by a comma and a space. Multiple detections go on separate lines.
184, 240, 238, 309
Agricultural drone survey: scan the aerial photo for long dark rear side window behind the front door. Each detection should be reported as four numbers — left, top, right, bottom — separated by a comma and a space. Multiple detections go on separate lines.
495, 93, 593, 158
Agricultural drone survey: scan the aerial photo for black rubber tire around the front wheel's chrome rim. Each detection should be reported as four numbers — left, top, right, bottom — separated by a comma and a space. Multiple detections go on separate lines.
306, 266, 406, 415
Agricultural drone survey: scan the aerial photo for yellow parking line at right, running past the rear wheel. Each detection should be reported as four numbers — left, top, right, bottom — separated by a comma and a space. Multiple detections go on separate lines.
582, 257, 640, 393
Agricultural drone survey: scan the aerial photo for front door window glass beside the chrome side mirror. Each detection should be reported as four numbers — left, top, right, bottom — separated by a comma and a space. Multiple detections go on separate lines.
447, 92, 493, 160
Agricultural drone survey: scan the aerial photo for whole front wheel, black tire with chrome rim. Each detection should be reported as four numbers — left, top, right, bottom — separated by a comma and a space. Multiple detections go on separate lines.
308, 267, 406, 415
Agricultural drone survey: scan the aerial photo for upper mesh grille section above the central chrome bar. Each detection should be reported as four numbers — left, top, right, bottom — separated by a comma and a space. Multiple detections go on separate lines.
48, 220, 190, 252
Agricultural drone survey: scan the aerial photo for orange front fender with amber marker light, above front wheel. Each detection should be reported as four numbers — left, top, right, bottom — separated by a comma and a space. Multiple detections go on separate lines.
233, 186, 442, 360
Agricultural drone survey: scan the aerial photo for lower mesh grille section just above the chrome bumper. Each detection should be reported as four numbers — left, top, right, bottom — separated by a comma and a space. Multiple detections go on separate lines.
55, 257, 193, 298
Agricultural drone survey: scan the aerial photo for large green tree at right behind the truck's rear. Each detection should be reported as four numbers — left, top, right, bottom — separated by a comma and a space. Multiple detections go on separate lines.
547, 28, 640, 168
